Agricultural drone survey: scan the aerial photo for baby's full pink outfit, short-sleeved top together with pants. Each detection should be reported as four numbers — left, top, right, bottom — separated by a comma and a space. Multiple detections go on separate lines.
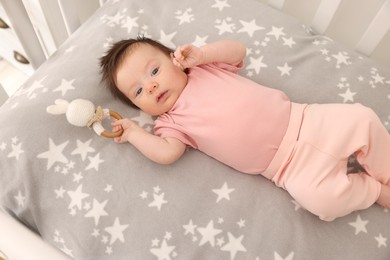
154, 61, 390, 221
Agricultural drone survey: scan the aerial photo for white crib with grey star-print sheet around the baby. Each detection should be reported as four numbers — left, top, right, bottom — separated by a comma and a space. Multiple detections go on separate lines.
0, 0, 390, 260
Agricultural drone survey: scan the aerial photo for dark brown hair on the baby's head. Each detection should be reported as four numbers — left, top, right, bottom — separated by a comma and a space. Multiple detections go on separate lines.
100, 36, 173, 107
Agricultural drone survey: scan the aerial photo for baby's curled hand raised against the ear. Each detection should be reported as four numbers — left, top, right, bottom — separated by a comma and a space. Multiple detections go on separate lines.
173, 44, 203, 69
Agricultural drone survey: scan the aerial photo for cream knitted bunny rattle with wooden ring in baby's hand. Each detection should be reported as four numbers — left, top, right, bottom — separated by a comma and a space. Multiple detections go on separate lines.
46, 99, 123, 138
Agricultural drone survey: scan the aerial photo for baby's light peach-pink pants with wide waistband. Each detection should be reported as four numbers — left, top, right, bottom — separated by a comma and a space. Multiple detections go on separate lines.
263, 104, 390, 221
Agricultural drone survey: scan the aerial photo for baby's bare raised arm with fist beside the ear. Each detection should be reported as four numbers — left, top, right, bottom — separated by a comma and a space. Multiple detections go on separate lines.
173, 40, 246, 69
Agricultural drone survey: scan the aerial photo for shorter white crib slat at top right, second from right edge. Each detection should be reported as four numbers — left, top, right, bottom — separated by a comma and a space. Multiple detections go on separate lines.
312, 0, 341, 34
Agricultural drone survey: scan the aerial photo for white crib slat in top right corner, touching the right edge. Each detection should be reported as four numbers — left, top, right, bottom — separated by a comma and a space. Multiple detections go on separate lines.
356, 1, 390, 56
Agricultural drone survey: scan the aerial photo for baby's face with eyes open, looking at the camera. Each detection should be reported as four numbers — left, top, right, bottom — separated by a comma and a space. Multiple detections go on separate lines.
116, 44, 187, 116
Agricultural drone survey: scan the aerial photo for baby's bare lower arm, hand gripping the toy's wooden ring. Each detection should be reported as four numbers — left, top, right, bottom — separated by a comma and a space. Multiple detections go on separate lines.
112, 118, 186, 164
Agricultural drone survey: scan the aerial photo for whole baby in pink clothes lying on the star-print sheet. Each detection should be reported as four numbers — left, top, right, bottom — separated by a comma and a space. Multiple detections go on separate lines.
101, 37, 390, 221
